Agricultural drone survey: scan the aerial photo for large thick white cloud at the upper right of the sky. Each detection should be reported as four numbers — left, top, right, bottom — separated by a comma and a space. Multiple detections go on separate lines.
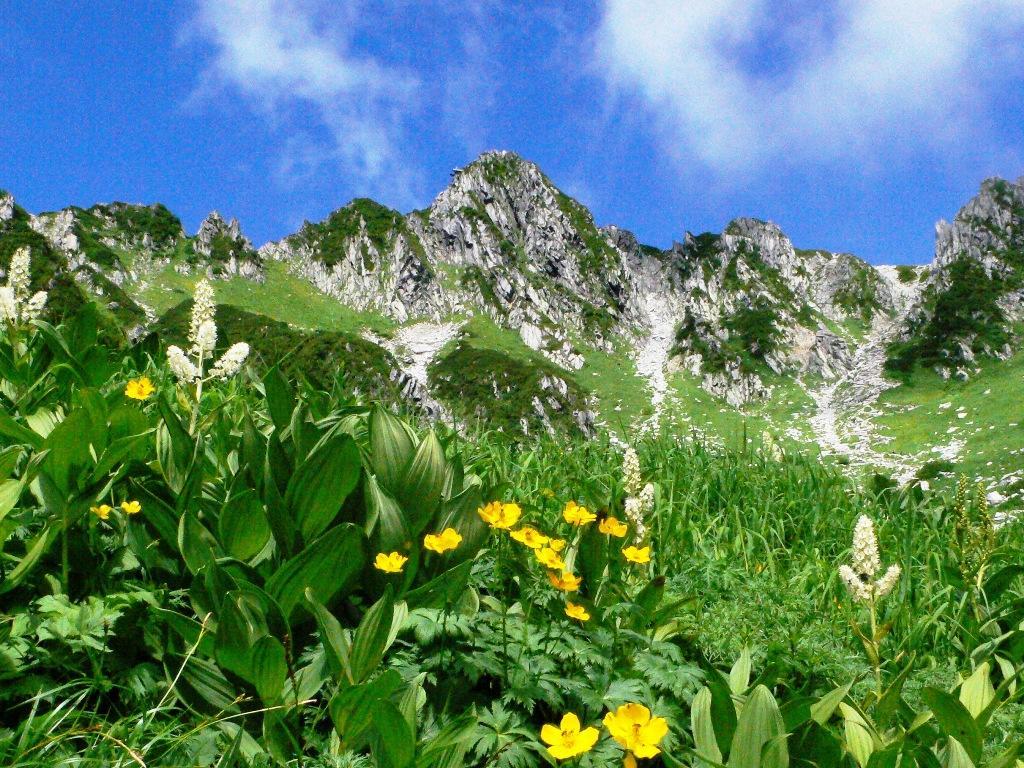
596, 0, 1024, 173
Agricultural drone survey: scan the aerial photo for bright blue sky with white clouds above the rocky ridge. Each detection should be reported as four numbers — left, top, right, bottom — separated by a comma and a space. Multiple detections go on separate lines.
0, 0, 1024, 263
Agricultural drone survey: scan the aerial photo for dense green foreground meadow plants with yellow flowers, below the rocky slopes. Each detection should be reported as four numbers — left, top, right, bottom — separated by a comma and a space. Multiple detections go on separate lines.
0, 278, 1024, 768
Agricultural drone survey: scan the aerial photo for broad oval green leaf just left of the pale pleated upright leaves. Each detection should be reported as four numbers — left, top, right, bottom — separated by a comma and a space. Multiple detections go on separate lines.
285, 433, 362, 542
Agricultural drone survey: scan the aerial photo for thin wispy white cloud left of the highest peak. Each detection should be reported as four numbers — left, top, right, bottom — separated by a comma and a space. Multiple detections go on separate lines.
193, 0, 422, 202
